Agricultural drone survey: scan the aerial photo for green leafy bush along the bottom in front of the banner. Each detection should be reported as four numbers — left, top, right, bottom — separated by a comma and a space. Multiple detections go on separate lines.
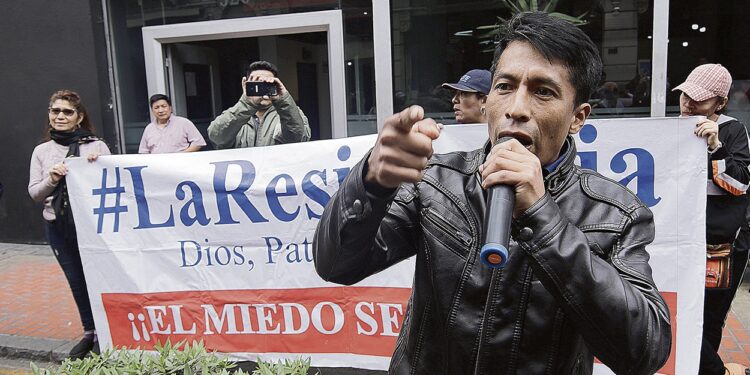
31, 341, 310, 375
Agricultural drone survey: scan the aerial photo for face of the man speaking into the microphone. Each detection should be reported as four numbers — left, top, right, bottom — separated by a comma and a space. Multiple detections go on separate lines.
486, 41, 591, 165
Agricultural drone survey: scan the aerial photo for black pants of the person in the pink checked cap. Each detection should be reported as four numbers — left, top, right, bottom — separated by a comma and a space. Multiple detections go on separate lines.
698, 234, 750, 375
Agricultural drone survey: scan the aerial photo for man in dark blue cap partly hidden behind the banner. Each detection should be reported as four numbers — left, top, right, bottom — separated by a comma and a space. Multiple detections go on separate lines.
443, 69, 492, 124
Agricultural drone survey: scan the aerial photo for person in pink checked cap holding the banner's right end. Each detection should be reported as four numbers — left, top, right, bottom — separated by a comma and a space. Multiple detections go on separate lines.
674, 64, 750, 375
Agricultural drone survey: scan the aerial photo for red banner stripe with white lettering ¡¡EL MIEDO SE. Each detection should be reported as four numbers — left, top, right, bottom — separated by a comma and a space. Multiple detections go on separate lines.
102, 287, 411, 357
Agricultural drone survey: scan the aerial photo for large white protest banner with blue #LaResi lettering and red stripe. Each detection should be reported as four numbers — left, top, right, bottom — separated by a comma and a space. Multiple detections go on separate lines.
67, 118, 706, 374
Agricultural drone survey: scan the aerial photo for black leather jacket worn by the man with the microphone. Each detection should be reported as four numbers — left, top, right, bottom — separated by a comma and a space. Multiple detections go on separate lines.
313, 137, 672, 374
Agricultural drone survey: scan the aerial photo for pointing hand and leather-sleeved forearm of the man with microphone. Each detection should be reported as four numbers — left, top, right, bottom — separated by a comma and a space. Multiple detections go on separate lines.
313, 106, 440, 284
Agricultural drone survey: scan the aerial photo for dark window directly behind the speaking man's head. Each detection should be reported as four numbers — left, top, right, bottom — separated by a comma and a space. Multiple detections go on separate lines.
391, 0, 653, 124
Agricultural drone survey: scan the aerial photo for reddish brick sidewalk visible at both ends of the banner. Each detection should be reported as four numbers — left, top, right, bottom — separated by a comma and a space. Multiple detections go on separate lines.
0, 244, 750, 374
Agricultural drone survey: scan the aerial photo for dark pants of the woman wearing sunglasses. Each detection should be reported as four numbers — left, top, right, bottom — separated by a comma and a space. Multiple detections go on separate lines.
47, 223, 94, 331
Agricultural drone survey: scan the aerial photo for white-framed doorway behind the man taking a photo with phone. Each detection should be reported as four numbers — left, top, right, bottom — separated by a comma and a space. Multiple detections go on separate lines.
142, 10, 347, 145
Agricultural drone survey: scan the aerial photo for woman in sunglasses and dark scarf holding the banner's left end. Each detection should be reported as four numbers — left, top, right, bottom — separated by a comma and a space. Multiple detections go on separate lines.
29, 90, 110, 358
